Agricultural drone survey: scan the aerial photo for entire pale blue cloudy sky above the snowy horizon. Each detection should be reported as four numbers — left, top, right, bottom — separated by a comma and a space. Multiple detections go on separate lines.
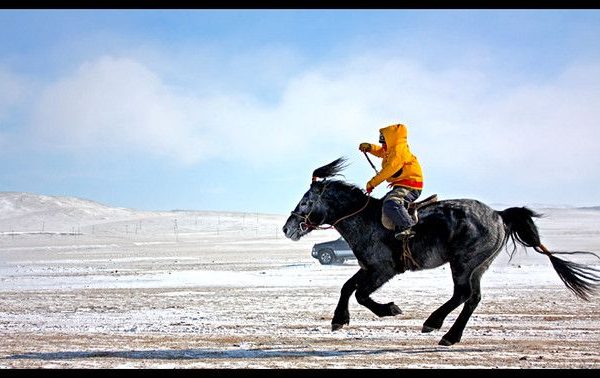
0, 9, 600, 214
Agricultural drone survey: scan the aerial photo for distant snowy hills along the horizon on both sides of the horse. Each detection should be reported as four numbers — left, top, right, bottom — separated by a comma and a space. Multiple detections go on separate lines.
0, 192, 600, 235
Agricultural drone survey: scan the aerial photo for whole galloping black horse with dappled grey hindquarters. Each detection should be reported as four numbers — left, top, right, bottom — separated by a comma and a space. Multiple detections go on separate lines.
282, 157, 600, 346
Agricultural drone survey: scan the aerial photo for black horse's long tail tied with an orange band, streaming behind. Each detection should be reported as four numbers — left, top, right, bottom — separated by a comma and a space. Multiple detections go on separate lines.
498, 207, 600, 301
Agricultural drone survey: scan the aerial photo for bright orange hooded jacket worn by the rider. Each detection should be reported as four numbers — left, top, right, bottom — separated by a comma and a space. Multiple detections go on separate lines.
368, 124, 423, 189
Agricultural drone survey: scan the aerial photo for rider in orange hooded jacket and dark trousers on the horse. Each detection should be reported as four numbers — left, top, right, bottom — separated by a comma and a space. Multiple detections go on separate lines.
358, 124, 423, 239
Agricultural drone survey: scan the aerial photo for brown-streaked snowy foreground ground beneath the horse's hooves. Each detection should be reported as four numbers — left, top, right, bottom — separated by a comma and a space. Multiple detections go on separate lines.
0, 286, 600, 368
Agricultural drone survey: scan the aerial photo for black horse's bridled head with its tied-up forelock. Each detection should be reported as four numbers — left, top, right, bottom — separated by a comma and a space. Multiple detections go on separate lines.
283, 158, 346, 241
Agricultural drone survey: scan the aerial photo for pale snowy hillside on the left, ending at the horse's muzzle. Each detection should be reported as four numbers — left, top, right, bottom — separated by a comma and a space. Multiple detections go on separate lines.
0, 192, 331, 245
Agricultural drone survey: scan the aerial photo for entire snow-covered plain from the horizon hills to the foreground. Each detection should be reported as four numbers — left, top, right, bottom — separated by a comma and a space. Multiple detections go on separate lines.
0, 193, 600, 368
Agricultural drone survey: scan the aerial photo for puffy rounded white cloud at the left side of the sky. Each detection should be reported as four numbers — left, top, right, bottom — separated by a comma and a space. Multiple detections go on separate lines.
34, 57, 210, 162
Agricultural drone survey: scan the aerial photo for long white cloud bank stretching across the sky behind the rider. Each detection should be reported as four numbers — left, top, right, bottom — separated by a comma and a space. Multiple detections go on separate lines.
27, 53, 600, 189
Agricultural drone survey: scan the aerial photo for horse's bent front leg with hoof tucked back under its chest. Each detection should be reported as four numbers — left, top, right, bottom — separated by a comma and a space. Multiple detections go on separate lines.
356, 268, 402, 317
